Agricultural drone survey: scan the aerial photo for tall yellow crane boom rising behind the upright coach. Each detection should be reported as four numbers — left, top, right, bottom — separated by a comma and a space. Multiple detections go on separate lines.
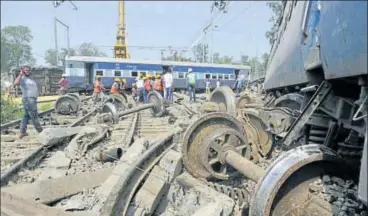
114, 0, 129, 59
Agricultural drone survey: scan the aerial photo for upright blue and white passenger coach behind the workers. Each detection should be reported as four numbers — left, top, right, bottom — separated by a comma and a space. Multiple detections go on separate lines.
65, 56, 250, 91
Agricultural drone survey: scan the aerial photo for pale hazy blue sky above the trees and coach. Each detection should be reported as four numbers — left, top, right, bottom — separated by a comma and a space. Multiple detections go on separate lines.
1, 1, 272, 65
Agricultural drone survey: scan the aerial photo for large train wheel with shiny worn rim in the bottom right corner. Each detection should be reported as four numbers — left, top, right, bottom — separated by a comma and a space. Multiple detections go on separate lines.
249, 144, 350, 216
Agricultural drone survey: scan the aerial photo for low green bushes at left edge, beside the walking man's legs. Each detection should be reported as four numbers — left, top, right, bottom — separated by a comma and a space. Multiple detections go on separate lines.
0, 91, 23, 124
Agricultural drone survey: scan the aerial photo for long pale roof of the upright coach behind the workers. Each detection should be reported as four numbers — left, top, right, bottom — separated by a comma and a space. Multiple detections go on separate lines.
65, 56, 250, 70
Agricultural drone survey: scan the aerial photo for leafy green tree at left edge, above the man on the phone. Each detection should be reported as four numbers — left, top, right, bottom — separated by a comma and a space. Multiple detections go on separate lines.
1, 25, 36, 72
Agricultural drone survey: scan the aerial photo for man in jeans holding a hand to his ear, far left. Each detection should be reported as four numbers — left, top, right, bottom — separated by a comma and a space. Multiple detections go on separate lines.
13, 66, 42, 138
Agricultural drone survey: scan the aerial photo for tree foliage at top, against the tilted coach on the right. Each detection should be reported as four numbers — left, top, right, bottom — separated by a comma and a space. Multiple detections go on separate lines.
265, 1, 286, 45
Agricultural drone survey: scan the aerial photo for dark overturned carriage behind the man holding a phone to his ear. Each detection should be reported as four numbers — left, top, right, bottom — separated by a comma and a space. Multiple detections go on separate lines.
8, 67, 63, 95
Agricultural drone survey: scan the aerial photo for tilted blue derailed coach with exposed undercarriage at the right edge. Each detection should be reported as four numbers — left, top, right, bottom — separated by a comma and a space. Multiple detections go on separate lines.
264, 1, 368, 209
